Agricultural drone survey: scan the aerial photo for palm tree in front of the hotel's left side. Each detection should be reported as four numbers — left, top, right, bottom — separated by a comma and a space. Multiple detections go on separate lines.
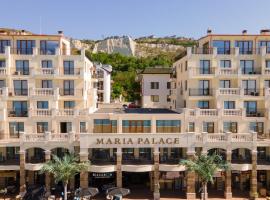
40, 154, 90, 200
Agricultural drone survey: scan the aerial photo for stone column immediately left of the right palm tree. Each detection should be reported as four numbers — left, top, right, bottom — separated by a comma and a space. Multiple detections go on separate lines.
186, 150, 196, 199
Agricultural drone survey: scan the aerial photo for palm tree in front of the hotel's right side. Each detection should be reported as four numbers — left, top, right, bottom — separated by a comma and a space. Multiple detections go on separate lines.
180, 153, 229, 200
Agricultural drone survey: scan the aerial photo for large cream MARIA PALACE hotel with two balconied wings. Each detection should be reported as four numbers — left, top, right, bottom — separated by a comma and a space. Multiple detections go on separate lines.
0, 30, 270, 199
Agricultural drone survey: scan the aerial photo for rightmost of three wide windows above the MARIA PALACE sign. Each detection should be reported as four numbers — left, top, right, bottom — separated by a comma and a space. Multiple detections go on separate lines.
156, 120, 181, 133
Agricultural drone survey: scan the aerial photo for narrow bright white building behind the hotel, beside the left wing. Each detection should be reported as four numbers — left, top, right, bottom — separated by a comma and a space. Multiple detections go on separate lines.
95, 63, 112, 103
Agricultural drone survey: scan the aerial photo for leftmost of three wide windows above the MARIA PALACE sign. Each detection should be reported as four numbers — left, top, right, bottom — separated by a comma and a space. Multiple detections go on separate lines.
94, 119, 117, 133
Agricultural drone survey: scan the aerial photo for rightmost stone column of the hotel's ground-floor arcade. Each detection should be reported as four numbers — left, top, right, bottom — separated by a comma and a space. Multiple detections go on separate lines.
250, 150, 258, 199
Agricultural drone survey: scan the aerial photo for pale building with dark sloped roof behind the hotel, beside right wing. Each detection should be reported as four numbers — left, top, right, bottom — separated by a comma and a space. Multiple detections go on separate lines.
138, 67, 172, 108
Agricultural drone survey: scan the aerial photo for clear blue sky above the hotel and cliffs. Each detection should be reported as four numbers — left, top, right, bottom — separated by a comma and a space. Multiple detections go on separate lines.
0, 0, 270, 39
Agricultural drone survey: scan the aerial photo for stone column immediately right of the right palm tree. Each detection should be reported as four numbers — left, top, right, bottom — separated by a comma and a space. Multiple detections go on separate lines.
224, 150, 232, 199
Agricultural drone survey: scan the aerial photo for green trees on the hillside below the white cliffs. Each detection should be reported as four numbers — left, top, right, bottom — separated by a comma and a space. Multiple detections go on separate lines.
86, 51, 173, 102
